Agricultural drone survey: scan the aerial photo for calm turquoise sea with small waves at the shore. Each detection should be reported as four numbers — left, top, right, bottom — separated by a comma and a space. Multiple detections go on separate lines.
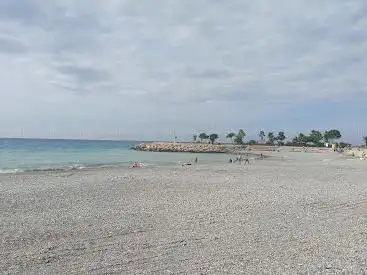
0, 138, 233, 173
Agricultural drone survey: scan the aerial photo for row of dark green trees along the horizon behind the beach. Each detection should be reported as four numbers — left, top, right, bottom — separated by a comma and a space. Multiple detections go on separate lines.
193, 129, 367, 147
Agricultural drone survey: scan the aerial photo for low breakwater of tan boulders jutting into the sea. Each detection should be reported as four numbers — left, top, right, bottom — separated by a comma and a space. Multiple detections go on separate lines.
132, 142, 233, 153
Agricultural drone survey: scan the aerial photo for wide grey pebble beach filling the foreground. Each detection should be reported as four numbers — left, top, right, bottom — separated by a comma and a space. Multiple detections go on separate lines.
0, 153, 367, 274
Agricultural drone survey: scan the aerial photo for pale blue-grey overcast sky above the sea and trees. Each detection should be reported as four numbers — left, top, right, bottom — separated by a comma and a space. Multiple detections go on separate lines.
0, 0, 367, 143
